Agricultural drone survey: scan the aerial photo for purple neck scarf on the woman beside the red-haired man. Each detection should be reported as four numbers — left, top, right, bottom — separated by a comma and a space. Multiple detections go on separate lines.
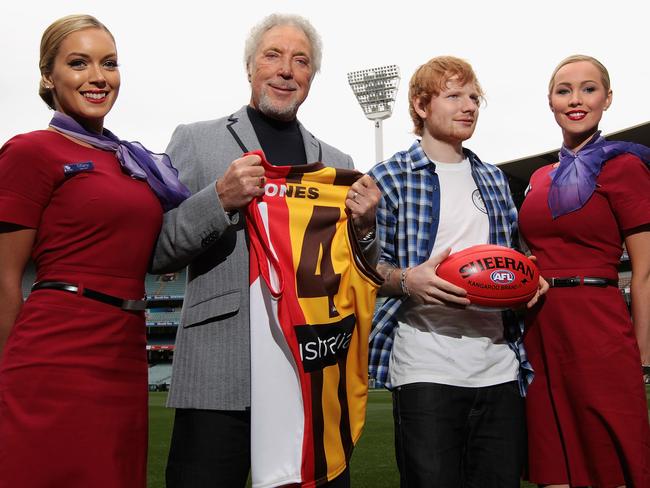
548, 131, 650, 219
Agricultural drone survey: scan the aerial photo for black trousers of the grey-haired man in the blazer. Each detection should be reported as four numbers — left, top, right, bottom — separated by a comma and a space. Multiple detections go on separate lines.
165, 408, 350, 488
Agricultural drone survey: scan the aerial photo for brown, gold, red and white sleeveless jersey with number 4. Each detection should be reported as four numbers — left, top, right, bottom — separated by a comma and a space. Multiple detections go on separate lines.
246, 152, 382, 488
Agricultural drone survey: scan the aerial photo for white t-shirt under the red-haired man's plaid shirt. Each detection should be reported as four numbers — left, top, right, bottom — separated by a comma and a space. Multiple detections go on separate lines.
389, 159, 519, 387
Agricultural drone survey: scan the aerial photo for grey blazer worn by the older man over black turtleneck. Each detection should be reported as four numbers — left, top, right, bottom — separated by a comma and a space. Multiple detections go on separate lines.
152, 107, 353, 410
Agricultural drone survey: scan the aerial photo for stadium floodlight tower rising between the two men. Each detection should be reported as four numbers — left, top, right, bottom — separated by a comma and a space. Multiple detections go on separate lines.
348, 64, 400, 162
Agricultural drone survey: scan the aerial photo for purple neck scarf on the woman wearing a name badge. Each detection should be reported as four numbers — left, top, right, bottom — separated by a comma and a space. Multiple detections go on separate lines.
50, 112, 190, 212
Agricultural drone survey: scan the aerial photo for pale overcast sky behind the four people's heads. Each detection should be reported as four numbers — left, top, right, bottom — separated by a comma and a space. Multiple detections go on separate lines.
0, 0, 650, 170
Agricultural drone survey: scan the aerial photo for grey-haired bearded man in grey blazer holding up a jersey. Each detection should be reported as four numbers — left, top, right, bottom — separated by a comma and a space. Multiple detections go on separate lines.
153, 14, 380, 488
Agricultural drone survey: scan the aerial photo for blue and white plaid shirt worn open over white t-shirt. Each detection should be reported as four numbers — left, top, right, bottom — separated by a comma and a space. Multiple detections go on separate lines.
369, 141, 533, 396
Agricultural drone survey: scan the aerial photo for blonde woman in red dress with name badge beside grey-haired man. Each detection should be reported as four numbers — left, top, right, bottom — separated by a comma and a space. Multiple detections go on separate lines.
0, 15, 188, 488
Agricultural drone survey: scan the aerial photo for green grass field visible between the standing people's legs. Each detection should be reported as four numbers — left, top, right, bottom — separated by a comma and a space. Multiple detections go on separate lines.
148, 388, 650, 488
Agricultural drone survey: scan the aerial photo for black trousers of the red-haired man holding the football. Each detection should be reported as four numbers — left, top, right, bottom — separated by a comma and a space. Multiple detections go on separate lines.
393, 382, 526, 488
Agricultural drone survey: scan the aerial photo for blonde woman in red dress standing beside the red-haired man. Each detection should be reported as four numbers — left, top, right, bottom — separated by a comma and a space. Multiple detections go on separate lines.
519, 55, 650, 488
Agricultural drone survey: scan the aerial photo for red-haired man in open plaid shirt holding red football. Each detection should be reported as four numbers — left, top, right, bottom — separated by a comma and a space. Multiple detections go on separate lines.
370, 56, 530, 488
